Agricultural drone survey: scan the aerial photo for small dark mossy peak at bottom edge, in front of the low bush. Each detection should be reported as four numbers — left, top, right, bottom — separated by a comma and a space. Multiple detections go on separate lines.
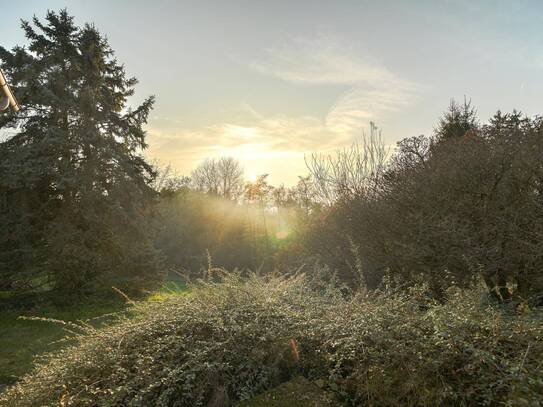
236, 376, 341, 407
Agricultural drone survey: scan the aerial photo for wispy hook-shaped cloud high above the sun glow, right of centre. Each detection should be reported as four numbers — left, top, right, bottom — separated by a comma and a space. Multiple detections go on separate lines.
250, 36, 422, 135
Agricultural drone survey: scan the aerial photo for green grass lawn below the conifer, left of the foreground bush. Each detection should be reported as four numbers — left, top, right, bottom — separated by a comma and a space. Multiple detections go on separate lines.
0, 281, 188, 389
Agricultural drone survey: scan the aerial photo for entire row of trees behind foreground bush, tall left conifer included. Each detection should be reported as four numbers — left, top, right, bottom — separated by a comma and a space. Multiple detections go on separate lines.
0, 11, 543, 303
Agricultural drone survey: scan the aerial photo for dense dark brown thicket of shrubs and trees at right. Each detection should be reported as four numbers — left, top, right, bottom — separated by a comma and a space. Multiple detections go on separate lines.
306, 103, 543, 303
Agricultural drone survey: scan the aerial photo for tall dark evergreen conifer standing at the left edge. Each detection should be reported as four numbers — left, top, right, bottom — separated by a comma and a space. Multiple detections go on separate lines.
0, 10, 162, 293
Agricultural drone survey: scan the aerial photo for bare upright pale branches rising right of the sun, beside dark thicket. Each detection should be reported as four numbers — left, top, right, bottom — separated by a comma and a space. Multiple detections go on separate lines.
305, 122, 389, 204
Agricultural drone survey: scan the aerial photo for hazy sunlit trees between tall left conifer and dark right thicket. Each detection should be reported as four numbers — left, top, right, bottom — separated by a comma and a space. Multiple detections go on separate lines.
154, 157, 317, 277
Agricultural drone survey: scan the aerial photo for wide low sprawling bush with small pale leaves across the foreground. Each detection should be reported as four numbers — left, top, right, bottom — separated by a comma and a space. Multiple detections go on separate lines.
0, 274, 543, 406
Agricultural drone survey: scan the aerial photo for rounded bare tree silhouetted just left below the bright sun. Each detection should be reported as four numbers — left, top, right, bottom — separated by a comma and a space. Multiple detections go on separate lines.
191, 157, 243, 200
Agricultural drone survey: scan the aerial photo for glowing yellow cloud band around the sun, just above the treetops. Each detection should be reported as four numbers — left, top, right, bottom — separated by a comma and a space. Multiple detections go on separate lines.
148, 102, 398, 184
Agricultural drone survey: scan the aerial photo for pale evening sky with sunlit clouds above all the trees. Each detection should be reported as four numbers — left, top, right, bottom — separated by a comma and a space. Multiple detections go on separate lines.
0, 0, 543, 185
